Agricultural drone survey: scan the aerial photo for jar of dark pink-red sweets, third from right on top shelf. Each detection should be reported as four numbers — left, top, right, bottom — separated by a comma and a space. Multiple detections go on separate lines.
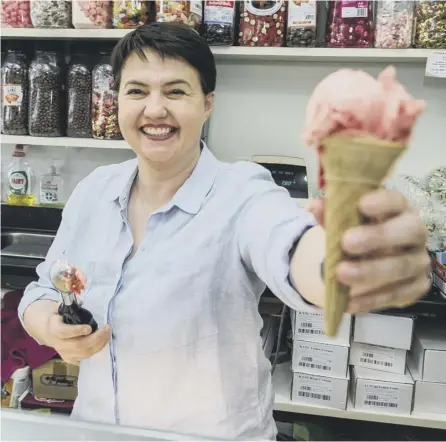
326, 0, 374, 48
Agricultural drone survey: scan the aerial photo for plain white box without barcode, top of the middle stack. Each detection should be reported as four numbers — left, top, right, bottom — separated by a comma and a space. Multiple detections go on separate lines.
353, 313, 415, 350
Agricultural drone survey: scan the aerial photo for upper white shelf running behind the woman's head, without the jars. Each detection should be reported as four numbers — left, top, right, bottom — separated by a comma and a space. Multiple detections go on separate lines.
2, 28, 433, 63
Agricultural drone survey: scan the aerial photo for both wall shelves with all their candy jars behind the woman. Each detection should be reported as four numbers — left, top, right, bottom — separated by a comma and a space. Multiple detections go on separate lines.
1, 0, 446, 149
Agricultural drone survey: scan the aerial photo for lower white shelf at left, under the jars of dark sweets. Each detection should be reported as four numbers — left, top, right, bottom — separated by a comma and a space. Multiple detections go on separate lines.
1, 135, 130, 149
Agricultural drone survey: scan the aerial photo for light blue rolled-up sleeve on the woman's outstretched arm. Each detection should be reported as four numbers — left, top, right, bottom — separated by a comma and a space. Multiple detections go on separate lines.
237, 168, 317, 310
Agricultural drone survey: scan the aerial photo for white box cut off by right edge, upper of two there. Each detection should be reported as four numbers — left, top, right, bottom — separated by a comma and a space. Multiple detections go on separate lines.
410, 326, 446, 384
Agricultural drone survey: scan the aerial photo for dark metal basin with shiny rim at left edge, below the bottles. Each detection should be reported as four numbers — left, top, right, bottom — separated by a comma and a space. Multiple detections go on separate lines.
1, 232, 55, 259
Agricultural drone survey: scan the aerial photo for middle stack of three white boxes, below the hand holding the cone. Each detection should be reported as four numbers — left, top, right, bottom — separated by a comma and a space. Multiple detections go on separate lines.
350, 314, 415, 414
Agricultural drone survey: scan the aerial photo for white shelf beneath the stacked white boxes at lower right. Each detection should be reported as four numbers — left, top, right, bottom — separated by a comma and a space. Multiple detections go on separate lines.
273, 364, 446, 430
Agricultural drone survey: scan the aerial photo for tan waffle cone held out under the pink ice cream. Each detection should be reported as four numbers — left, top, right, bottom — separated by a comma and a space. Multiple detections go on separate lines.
322, 135, 405, 336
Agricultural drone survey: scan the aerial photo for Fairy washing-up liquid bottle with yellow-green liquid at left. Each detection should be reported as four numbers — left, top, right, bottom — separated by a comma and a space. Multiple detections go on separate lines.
6, 144, 37, 206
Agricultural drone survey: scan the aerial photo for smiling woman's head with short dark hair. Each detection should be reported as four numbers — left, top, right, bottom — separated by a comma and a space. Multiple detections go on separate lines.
112, 24, 216, 168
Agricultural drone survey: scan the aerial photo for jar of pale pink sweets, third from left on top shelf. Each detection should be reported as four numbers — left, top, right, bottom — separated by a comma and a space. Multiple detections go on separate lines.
72, 0, 112, 29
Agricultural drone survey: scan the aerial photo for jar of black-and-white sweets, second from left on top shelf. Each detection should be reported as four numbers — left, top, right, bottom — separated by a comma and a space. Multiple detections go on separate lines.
31, 0, 71, 28
